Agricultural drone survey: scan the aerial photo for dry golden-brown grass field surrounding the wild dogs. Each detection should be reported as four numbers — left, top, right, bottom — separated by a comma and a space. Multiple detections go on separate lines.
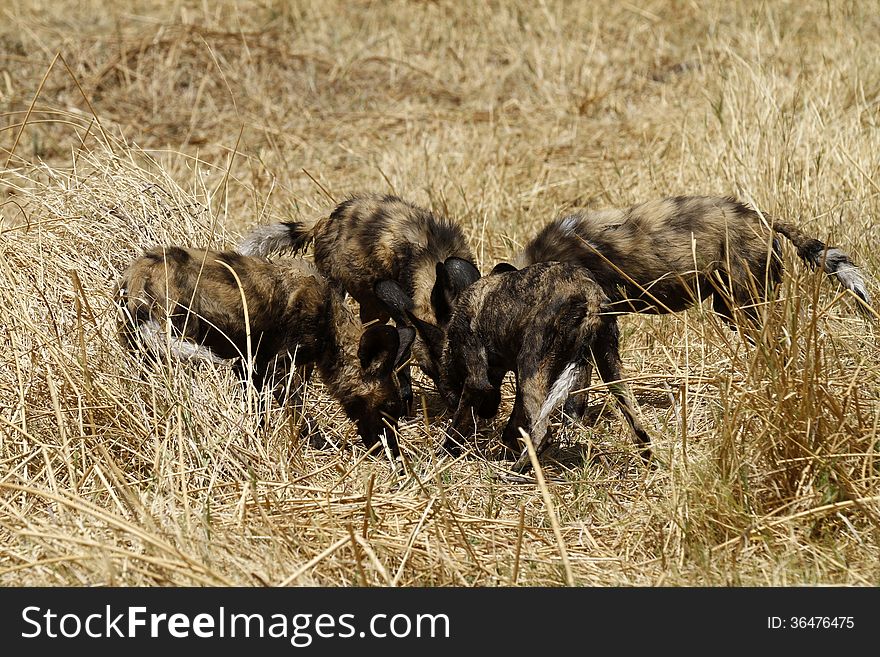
0, 0, 880, 587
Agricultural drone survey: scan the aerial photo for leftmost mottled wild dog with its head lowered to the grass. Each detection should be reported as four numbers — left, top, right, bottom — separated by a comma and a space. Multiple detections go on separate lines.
117, 246, 415, 454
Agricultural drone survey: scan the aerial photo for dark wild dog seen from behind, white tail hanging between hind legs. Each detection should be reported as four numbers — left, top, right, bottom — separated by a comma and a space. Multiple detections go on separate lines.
382, 262, 649, 470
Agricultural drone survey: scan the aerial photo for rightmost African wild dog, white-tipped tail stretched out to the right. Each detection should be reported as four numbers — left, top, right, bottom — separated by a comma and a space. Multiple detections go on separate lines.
515, 196, 871, 417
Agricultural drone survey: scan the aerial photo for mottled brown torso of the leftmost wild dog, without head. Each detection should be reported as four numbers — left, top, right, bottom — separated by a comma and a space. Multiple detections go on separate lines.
117, 246, 324, 369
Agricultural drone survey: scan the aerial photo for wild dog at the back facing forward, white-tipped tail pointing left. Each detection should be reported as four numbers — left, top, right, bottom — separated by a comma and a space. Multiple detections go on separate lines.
239, 194, 480, 401
